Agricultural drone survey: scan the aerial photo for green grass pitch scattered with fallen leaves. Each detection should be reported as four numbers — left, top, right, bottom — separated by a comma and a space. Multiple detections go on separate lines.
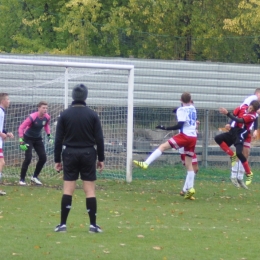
0, 167, 260, 260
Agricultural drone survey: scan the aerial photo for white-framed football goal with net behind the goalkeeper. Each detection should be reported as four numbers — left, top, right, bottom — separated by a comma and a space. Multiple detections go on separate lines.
0, 58, 134, 182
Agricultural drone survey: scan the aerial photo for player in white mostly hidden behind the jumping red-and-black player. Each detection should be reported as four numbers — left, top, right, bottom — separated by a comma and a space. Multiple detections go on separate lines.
228, 88, 260, 189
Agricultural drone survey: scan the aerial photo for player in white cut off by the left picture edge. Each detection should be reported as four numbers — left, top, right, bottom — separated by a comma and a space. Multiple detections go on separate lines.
0, 93, 14, 195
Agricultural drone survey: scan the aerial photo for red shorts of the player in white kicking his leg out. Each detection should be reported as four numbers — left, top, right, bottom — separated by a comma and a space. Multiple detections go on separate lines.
168, 133, 197, 157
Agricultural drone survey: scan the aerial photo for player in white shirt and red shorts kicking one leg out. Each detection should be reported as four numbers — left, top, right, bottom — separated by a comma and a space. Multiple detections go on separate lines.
134, 92, 197, 199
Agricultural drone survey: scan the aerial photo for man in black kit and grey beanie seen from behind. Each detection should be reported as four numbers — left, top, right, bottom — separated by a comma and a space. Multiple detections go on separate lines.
54, 84, 105, 233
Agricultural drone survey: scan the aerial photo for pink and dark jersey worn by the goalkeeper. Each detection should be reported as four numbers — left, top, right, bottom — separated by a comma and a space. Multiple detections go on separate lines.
18, 112, 51, 138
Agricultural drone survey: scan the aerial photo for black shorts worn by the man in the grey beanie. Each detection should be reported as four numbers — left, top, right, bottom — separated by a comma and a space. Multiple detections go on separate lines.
62, 147, 97, 181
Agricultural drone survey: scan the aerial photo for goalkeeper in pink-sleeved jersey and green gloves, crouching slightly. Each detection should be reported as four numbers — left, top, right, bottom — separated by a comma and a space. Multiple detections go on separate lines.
18, 101, 53, 186
